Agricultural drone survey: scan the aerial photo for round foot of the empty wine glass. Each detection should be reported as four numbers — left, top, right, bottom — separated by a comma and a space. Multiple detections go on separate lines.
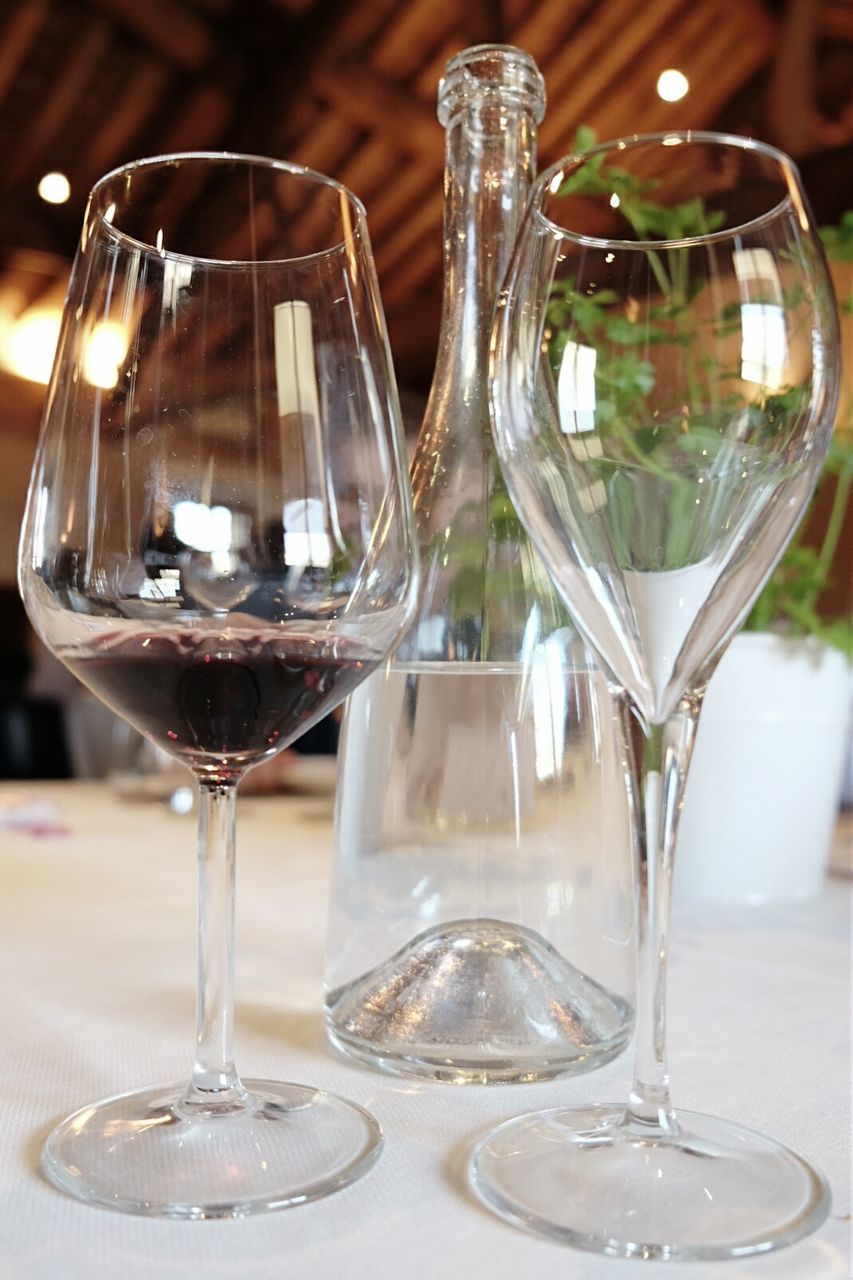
471, 1106, 830, 1261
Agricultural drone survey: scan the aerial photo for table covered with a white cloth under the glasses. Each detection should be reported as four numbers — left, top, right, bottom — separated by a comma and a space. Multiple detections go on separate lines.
0, 762, 850, 1280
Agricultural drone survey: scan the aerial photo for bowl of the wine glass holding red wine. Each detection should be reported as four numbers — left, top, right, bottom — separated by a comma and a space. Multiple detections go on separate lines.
22, 156, 409, 780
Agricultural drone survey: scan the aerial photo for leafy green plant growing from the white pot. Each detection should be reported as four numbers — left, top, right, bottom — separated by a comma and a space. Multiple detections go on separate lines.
547, 128, 853, 655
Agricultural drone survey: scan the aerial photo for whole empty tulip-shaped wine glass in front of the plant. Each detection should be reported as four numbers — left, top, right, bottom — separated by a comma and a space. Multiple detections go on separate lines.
471, 133, 838, 1260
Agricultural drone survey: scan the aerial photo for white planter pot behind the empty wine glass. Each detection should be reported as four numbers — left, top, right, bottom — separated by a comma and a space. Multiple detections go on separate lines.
674, 632, 850, 902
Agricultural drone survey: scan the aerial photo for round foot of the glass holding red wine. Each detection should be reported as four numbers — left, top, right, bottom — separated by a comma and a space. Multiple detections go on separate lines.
42, 1080, 382, 1219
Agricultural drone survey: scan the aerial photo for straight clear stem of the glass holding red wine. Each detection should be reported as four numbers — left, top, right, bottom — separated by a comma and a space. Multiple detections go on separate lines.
183, 782, 247, 1110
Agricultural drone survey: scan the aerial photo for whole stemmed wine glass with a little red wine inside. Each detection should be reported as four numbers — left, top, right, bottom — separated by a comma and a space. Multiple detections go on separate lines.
19, 154, 416, 1217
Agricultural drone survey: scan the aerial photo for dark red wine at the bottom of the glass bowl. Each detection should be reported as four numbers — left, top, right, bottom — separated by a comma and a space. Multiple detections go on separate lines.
63, 631, 378, 778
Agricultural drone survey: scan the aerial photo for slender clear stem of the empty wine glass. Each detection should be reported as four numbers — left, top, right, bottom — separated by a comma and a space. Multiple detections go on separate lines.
624, 695, 701, 1135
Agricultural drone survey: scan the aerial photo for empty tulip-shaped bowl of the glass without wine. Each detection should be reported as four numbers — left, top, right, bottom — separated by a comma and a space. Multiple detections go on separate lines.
494, 134, 835, 723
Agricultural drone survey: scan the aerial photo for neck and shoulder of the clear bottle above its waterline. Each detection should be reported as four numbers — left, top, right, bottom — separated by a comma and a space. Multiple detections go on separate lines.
398, 83, 548, 662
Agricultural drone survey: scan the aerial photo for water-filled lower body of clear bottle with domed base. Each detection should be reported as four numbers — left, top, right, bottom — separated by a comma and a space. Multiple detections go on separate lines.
327, 650, 634, 1084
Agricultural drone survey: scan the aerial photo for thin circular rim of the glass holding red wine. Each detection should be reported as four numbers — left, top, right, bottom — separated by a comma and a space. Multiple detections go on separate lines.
85, 151, 366, 269
